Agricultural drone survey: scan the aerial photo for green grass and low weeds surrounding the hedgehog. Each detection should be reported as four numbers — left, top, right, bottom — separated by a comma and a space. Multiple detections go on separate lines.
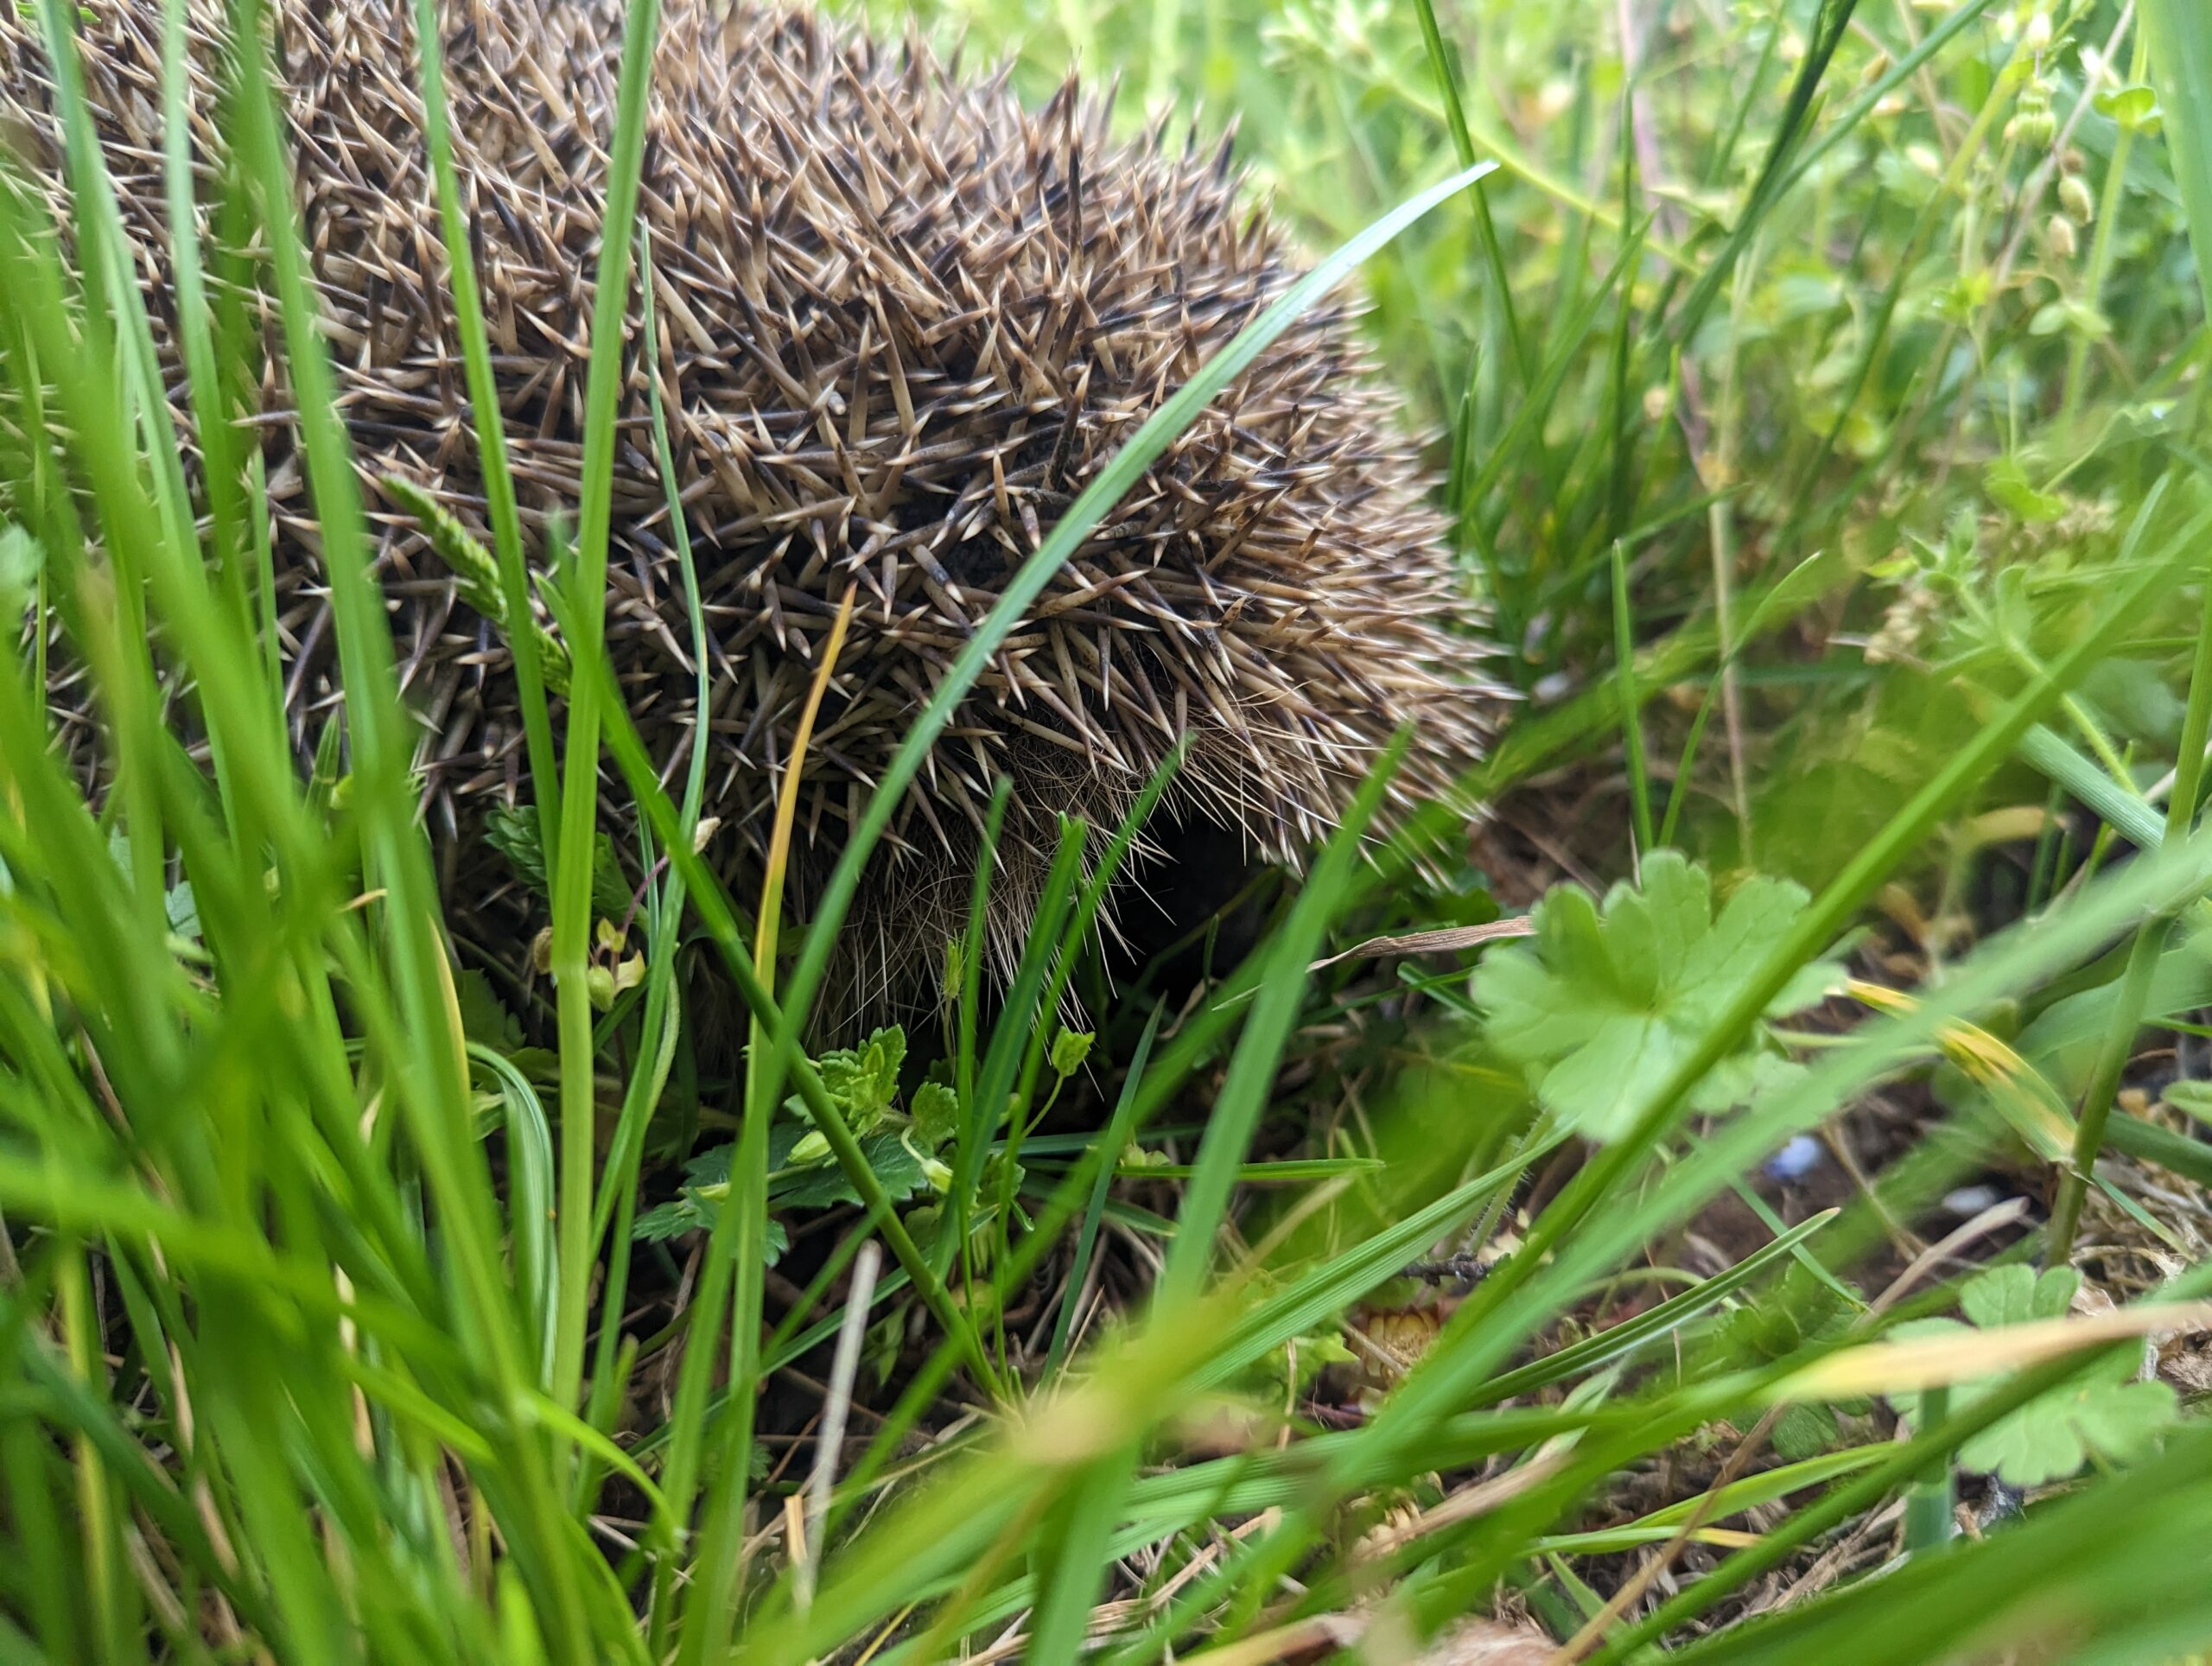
0, 0, 2212, 1662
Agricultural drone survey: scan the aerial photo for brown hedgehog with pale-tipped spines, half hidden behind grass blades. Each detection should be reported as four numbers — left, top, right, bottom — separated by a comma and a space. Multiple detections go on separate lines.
0, 0, 1491, 1013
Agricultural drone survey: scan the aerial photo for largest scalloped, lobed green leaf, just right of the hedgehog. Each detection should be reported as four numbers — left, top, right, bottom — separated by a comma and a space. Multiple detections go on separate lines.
1476, 849, 1842, 1140
